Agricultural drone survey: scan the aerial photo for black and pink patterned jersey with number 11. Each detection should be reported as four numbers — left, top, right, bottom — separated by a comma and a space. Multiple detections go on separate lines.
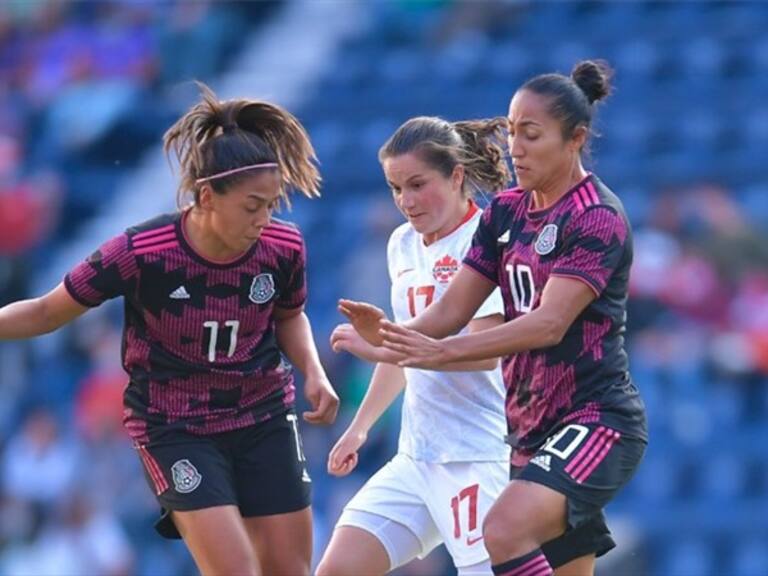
64, 211, 306, 443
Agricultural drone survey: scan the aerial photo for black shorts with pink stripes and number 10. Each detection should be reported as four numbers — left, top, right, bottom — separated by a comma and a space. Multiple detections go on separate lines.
512, 423, 647, 568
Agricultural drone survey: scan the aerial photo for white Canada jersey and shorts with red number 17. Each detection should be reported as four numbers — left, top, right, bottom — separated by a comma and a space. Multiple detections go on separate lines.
338, 204, 509, 569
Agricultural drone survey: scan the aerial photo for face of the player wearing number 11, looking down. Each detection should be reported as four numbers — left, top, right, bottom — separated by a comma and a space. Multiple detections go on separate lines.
210, 170, 280, 252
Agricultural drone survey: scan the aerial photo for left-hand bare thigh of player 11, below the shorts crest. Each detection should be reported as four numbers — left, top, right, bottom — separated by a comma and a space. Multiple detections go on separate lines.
173, 506, 259, 576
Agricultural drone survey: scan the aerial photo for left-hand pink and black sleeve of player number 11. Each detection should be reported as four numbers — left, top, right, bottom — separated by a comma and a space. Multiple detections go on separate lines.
64, 234, 138, 307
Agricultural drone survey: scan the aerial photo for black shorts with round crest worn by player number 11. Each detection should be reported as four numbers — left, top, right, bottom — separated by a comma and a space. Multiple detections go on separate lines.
136, 412, 312, 538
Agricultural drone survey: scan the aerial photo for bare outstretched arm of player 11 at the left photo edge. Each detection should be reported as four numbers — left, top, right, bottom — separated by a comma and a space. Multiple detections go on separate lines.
0, 283, 88, 340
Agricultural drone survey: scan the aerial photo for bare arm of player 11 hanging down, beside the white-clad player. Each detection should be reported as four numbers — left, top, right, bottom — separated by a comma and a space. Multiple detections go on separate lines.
272, 306, 339, 424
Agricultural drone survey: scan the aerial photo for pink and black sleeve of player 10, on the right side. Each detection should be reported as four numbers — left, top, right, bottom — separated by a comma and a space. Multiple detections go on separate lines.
551, 205, 629, 296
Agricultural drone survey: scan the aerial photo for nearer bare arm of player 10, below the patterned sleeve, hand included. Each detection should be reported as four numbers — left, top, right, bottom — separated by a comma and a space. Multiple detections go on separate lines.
382, 276, 596, 367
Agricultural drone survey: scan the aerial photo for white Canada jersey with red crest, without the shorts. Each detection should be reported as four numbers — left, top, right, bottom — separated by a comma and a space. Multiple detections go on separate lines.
387, 208, 509, 463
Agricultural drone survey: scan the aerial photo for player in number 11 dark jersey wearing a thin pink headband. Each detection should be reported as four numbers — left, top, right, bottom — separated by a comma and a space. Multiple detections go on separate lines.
0, 85, 338, 575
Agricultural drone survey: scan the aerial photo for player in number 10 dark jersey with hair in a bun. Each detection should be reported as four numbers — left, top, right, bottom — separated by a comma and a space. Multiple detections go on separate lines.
341, 61, 647, 576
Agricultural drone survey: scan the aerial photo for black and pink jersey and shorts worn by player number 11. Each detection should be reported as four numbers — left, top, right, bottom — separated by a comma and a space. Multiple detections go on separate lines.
64, 211, 310, 537
